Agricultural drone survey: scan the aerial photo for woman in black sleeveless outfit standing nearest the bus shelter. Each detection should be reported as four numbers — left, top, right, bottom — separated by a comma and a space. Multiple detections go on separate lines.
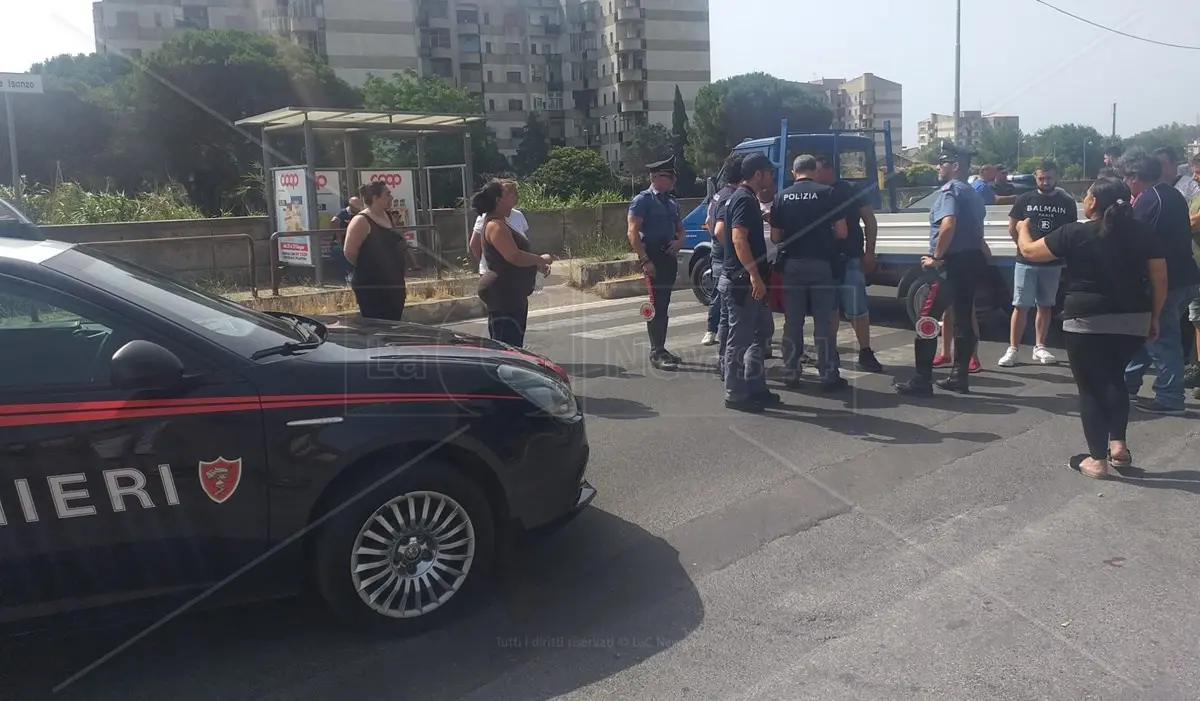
342, 182, 408, 322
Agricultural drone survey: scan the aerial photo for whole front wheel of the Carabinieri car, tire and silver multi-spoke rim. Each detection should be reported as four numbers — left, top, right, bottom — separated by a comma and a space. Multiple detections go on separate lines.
313, 460, 496, 636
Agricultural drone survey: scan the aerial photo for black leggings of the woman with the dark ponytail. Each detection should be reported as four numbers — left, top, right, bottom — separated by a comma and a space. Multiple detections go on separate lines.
1063, 332, 1146, 460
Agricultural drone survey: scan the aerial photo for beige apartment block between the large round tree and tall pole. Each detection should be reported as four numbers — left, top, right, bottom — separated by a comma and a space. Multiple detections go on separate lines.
810, 73, 904, 158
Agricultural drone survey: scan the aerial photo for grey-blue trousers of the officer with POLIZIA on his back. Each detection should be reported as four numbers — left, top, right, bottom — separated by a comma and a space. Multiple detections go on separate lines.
784, 258, 841, 381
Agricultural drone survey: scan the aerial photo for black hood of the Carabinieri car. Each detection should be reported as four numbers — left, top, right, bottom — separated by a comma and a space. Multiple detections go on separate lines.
312, 316, 570, 383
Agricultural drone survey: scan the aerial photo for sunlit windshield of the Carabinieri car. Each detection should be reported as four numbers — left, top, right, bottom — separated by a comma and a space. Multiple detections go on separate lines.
44, 248, 308, 358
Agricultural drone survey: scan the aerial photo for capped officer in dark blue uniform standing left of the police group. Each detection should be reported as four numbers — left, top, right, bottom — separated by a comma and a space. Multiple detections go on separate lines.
628, 156, 684, 370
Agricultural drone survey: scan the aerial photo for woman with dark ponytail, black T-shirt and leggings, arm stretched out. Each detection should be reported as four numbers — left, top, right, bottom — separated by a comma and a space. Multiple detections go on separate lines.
1016, 178, 1166, 478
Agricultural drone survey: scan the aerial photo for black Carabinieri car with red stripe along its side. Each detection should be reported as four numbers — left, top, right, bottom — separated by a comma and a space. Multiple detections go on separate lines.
0, 198, 595, 634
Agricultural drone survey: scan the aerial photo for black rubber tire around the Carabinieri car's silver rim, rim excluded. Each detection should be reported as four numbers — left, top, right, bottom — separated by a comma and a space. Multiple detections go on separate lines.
313, 459, 496, 637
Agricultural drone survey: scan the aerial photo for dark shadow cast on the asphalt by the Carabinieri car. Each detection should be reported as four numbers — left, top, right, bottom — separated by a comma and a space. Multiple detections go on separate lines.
0, 509, 704, 701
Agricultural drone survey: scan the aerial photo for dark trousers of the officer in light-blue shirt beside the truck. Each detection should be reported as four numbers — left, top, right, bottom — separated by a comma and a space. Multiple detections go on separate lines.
913, 250, 988, 383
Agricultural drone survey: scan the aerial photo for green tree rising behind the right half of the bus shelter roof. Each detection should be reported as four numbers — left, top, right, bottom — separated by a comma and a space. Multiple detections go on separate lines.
362, 71, 510, 206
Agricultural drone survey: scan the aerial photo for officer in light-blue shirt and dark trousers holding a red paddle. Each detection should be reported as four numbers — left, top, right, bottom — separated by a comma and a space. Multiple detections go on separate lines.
894, 142, 988, 396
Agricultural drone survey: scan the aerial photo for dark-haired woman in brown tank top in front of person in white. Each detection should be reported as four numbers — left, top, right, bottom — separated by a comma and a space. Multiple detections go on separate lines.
470, 180, 553, 348
